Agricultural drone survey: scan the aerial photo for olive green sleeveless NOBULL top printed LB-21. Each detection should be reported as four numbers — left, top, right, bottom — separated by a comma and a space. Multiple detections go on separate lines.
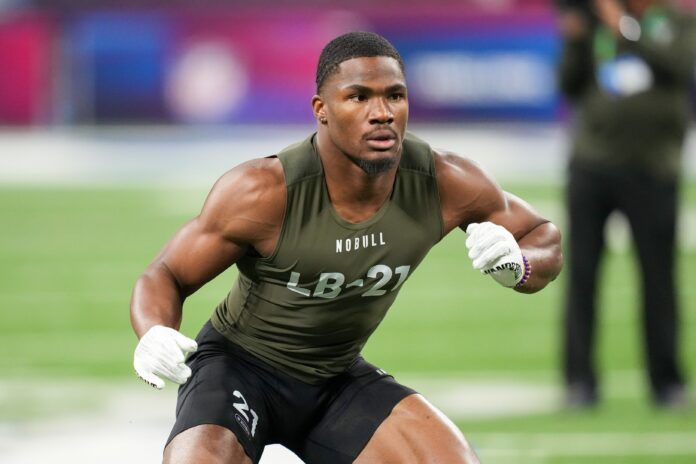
212, 131, 443, 383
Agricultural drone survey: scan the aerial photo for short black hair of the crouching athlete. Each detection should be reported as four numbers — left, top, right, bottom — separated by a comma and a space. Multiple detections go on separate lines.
316, 32, 404, 93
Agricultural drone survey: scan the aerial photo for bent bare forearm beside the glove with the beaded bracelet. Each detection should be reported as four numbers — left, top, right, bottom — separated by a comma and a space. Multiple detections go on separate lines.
516, 222, 563, 293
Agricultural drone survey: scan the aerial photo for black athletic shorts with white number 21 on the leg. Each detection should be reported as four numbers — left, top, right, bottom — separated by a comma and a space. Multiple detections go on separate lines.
167, 322, 415, 464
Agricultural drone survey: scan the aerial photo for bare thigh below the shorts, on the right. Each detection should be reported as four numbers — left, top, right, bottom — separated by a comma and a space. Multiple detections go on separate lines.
355, 394, 479, 464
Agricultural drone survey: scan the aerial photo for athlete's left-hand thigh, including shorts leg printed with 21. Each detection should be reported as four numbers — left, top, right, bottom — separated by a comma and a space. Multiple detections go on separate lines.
167, 324, 273, 462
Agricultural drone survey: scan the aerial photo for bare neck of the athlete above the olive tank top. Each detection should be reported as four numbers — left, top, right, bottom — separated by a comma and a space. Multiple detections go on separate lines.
316, 128, 397, 222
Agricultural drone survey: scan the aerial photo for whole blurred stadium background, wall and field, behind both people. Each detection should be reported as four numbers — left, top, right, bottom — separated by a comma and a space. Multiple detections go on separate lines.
0, 0, 696, 464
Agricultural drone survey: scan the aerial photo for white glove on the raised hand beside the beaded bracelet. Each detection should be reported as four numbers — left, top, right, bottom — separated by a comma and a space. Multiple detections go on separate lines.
466, 222, 528, 287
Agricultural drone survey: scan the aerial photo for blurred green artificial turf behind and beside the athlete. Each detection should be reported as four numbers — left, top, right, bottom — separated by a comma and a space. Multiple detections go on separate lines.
0, 184, 696, 464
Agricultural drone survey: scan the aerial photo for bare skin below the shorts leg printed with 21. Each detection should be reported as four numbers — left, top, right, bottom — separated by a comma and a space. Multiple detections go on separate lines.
162, 424, 251, 464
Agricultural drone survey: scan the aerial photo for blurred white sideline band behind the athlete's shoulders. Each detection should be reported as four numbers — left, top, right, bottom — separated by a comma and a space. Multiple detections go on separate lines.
0, 124, 568, 186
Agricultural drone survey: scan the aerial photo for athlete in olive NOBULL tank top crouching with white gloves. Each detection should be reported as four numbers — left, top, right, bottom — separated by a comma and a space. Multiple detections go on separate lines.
131, 32, 562, 463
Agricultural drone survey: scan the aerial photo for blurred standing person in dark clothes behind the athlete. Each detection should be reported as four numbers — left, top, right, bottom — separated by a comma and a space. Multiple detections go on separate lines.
559, 0, 696, 408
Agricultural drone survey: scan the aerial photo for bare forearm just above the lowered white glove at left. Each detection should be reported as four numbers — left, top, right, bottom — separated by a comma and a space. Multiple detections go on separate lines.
130, 263, 185, 338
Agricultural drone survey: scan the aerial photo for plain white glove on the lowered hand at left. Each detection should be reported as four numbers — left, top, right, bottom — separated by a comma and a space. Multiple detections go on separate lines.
133, 325, 198, 390
